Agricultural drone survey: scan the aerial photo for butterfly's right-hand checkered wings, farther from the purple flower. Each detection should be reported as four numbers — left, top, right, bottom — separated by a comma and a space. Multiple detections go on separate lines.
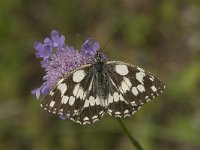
107, 61, 165, 118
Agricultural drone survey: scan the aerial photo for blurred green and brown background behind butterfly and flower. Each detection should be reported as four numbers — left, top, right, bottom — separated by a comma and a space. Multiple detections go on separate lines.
0, 0, 200, 150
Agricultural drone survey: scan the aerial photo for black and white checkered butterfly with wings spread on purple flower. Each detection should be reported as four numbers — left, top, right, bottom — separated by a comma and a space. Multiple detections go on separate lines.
41, 52, 165, 125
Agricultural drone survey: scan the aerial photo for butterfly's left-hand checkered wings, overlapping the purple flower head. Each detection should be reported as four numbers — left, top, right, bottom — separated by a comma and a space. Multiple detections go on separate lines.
41, 64, 105, 124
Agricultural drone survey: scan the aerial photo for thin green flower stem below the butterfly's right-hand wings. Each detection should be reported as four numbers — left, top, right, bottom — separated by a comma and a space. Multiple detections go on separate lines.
116, 118, 144, 150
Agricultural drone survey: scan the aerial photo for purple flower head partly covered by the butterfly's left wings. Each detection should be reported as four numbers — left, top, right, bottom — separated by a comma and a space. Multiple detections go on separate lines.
32, 30, 107, 99
